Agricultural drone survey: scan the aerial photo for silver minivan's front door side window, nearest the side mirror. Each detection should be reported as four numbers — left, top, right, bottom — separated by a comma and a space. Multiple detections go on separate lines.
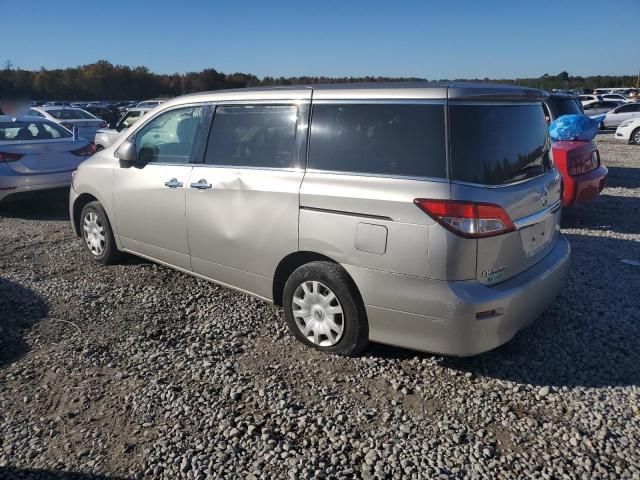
135, 106, 205, 163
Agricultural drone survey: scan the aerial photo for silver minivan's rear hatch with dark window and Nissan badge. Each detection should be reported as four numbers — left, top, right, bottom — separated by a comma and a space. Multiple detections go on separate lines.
449, 101, 562, 285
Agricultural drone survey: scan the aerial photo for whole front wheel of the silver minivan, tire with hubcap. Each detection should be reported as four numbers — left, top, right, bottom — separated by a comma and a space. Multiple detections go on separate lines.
80, 201, 120, 264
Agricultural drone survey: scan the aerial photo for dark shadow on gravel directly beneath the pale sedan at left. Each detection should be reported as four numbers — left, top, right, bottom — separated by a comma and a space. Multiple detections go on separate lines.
0, 188, 69, 220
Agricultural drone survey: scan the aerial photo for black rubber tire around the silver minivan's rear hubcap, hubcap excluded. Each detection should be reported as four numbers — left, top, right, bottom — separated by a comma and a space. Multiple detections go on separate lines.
283, 262, 369, 355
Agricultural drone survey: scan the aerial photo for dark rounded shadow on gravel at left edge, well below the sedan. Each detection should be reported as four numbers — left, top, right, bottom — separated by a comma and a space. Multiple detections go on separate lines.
0, 277, 49, 368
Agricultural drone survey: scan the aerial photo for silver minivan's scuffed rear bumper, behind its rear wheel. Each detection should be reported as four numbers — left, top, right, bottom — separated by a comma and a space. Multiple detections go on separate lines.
345, 236, 571, 356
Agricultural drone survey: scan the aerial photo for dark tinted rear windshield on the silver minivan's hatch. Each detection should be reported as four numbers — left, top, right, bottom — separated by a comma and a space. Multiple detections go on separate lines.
449, 104, 552, 185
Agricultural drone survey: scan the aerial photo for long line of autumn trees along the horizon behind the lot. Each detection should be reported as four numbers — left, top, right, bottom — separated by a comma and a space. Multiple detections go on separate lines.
0, 60, 637, 100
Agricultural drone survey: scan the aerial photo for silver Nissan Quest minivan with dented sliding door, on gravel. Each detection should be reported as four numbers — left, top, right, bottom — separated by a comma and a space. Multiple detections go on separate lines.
70, 83, 570, 355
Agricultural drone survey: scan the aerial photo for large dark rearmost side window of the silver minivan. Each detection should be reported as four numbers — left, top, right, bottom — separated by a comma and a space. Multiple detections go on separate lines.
309, 103, 446, 178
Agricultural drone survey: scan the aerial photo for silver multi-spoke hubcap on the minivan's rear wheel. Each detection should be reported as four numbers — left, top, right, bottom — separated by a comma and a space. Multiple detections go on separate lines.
292, 281, 344, 347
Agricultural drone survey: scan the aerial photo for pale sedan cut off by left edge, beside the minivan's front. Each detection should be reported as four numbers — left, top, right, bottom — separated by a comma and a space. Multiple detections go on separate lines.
0, 115, 95, 201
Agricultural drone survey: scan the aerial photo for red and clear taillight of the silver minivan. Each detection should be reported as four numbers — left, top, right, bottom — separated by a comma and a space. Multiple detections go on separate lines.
414, 198, 516, 238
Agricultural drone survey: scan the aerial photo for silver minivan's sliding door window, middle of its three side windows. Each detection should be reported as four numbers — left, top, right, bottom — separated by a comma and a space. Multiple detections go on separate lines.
205, 105, 306, 168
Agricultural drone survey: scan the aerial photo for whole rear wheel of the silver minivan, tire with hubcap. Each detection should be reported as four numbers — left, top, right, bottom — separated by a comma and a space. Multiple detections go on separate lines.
283, 262, 369, 356
